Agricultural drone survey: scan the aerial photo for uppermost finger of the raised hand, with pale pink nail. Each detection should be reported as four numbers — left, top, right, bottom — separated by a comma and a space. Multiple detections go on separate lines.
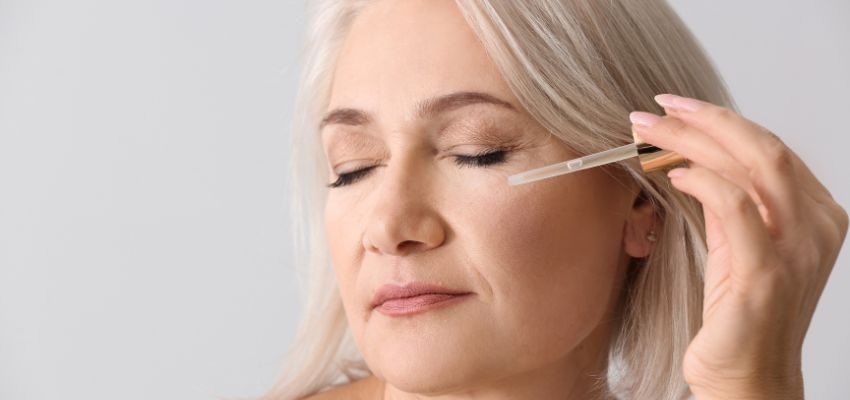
656, 94, 800, 231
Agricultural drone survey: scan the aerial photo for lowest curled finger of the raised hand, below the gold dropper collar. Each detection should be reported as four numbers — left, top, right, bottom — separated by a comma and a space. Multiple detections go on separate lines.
669, 166, 774, 278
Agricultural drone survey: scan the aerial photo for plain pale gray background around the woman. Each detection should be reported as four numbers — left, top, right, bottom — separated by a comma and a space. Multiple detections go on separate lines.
0, 0, 850, 400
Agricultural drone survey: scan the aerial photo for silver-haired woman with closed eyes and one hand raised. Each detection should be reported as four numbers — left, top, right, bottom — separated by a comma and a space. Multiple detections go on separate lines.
264, 0, 847, 400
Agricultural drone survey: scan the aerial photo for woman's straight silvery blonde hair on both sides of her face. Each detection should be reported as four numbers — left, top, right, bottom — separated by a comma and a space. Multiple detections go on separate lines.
262, 0, 735, 400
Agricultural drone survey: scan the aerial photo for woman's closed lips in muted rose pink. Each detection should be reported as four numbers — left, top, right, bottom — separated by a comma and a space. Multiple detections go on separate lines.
371, 282, 470, 313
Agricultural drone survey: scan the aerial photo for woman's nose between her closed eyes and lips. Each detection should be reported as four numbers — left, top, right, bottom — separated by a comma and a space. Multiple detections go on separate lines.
363, 166, 446, 256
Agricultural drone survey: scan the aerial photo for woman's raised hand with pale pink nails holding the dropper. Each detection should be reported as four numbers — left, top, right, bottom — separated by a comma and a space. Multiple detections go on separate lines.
631, 94, 848, 400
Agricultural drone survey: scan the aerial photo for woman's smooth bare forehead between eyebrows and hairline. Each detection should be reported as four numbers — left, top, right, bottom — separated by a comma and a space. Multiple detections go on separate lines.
329, 0, 514, 114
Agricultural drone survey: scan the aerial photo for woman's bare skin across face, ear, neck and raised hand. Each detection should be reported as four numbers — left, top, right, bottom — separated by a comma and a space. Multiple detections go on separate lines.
316, 0, 847, 400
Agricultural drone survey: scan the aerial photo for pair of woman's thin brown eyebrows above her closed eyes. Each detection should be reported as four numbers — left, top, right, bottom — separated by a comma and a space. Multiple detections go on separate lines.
319, 92, 516, 131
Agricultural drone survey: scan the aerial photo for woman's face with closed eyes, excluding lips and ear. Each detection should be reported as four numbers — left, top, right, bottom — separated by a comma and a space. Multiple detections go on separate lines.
321, 0, 637, 393
